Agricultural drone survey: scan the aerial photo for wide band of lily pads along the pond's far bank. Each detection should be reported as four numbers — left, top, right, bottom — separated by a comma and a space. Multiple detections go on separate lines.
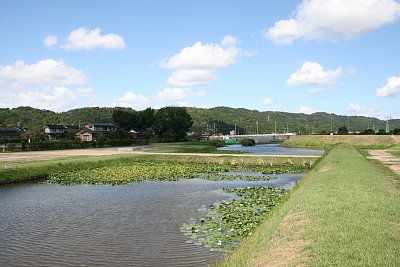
47, 161, 307, 185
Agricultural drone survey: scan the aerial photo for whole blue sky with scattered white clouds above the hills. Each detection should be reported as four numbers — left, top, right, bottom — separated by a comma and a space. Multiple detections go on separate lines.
0, 0, 400, 119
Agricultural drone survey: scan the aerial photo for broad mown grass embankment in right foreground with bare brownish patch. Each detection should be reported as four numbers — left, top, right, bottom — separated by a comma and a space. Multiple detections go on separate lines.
217, 145, 400, 266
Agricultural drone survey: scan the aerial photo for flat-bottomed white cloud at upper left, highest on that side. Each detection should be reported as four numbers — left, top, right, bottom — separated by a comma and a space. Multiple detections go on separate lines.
62, 28, 125, 51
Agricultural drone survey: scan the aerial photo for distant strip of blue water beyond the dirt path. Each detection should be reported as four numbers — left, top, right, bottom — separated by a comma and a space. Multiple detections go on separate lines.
218, 144, 324, 155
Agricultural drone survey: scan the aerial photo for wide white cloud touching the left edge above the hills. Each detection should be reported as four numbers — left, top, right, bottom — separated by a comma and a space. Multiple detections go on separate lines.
0, 59, 87, 86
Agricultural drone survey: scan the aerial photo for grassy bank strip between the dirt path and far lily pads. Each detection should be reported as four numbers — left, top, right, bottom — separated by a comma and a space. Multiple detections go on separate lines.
0, 154, 315, 184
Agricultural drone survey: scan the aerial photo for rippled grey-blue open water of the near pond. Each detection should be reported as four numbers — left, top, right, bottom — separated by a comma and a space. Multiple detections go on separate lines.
0, 174, 302, 266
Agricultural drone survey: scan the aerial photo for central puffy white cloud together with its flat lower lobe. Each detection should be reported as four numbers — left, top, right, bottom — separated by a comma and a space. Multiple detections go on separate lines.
160, 36, 241, 87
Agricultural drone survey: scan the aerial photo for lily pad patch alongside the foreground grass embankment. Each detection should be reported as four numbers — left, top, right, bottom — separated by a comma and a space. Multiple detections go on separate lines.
181, 187, 285, 252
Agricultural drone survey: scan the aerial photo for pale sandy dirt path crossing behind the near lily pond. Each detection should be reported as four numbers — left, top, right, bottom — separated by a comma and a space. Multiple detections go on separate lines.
0, 147, 319, 163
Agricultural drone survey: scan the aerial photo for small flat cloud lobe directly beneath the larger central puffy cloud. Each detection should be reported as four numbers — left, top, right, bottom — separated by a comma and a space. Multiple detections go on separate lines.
168, 69, 216, 87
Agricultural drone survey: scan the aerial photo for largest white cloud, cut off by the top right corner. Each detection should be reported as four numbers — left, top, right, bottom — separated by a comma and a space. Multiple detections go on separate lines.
263, 0, 400, 45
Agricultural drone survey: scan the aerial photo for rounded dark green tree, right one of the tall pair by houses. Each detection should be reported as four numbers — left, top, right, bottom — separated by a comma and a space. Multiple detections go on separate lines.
154, 107, 193, 142
